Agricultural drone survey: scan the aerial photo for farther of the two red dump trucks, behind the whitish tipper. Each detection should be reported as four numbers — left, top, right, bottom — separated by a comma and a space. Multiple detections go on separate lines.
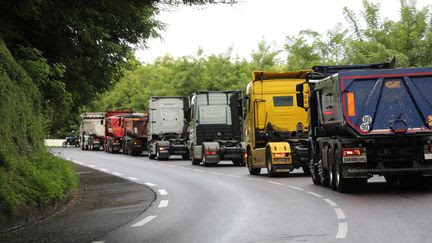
104, 110, 133, 153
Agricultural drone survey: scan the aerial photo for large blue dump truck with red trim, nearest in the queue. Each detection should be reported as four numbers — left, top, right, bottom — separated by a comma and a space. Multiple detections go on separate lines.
297, 63, 432, 192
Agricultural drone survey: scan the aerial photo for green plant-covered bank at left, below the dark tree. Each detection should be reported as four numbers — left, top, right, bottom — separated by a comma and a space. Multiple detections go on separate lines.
0, 40, 78, 215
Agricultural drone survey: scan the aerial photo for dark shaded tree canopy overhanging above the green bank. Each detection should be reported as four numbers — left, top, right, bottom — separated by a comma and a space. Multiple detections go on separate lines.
0, 0, 232, 136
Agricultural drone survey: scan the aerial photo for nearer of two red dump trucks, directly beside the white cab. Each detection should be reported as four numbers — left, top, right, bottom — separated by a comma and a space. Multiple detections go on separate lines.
122, 113, 148, 156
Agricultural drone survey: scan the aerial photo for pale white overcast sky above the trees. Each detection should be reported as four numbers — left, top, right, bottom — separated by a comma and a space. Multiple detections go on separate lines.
136, 0, 431, 63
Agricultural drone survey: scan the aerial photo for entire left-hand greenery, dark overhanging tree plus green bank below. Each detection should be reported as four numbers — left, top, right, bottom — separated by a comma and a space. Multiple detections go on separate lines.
0, 0, 228, 216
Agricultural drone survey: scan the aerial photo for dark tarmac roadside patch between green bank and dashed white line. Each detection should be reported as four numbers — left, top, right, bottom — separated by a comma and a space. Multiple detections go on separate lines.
0, 160, 156, 242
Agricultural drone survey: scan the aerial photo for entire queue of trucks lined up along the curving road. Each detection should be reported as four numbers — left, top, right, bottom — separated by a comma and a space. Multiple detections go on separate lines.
80, 60, 432, 192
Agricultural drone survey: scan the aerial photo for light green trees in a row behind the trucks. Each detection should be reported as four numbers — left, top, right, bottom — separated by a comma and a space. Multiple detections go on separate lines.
96, 1, 432, 110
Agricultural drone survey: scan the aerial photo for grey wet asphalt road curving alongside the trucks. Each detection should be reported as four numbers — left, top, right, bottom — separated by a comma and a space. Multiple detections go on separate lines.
53, 148, 432, 242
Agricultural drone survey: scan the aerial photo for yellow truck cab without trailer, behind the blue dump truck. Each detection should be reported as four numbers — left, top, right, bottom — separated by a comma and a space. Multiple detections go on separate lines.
243, 70, 309, 176
